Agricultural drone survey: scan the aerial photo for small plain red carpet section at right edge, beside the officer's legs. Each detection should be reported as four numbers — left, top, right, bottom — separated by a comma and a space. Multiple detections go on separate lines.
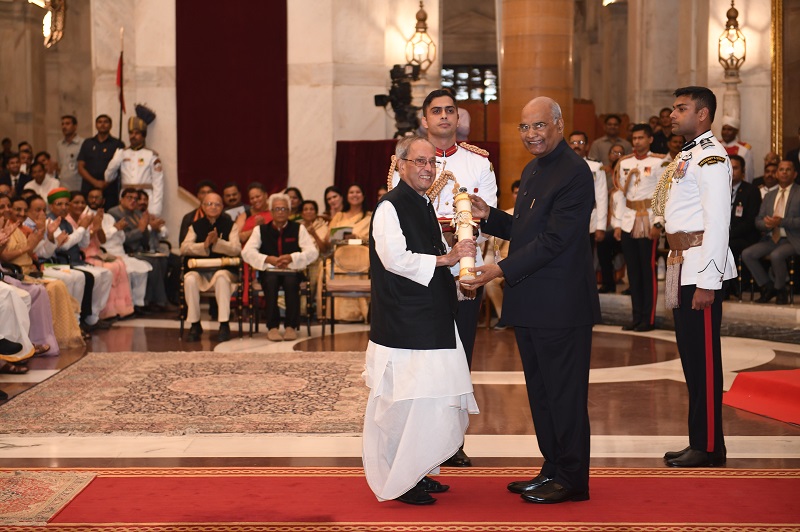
722, 369, 800, 425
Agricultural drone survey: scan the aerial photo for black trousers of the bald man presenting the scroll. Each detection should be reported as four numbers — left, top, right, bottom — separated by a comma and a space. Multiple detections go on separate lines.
514, 325, 592, 491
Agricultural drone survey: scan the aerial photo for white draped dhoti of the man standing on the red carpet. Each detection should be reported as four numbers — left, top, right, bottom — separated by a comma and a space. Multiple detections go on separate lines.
362, 323, 478, 501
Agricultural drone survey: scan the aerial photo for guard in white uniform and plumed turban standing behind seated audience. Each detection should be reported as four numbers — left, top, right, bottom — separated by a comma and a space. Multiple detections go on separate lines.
105, 116, 164, 218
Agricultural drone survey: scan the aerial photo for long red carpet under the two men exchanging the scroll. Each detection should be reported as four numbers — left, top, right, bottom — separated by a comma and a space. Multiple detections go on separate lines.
8, 468, 800, 532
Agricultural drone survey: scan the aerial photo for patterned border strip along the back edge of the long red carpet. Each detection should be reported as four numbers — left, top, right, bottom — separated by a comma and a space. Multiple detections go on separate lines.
0, 467, 800, 479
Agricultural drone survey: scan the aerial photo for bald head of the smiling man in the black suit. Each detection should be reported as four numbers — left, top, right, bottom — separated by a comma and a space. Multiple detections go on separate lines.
519, 96, 564, 157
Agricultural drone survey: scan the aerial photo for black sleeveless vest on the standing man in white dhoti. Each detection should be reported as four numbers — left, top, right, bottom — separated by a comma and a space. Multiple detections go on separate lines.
369, 180, 458, 349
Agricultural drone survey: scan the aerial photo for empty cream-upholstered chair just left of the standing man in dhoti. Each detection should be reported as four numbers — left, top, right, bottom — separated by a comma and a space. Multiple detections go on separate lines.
320, 241, 372, 336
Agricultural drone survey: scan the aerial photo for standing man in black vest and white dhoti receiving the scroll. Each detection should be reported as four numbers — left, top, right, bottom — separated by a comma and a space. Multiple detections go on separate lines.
363, 137, 478, 504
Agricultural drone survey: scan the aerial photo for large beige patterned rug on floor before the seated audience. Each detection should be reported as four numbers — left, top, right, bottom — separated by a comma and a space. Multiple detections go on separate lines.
0, 352, 367, 434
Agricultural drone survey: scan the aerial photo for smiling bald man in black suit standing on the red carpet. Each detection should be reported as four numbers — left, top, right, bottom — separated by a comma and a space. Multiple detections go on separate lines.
462, 97, 600, 503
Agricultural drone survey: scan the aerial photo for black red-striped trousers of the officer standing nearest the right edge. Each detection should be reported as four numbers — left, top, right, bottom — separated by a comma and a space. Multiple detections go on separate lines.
672, 285, 725, 453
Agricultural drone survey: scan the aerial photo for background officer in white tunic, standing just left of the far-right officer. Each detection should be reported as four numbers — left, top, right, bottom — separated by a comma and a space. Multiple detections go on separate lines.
611, 124, 664, 332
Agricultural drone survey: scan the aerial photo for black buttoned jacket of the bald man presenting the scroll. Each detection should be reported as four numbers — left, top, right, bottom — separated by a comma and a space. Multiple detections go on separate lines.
482, 139, 600, 328
